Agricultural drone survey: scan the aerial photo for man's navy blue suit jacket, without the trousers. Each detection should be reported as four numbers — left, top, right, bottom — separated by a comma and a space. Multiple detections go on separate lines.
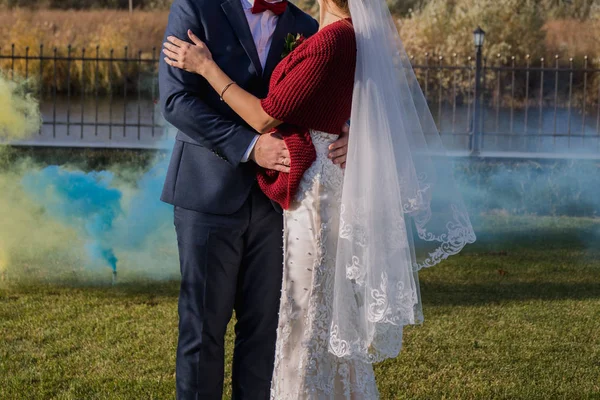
159, 0, 318, 215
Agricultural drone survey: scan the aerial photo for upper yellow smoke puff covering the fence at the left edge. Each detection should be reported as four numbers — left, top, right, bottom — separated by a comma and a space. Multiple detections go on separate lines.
0, 75, 42, 142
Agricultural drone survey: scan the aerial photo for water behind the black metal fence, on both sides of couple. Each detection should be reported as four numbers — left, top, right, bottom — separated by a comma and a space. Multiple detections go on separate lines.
8, 96, 600, 157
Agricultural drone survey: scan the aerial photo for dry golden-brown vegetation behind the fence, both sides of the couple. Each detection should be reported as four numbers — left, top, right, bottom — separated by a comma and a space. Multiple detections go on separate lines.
0, 7, 600, 101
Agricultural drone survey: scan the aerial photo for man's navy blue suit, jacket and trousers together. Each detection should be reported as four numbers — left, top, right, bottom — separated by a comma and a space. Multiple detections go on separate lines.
159, 0, 318, 400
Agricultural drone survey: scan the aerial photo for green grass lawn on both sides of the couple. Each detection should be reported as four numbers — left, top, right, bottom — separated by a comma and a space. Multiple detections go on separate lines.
0, 217, 600, 400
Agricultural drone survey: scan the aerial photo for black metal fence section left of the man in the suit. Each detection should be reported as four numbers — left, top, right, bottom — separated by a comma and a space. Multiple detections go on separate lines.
0, 45, 162, 148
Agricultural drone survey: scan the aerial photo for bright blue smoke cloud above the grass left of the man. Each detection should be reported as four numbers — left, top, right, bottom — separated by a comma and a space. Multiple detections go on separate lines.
22, 147, 172, 271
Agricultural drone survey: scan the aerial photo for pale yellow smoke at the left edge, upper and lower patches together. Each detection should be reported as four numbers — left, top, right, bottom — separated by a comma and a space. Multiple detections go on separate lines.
0, 73, 78, 282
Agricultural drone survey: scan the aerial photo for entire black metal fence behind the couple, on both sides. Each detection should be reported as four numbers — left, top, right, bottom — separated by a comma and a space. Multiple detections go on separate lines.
0, 46, 600, 157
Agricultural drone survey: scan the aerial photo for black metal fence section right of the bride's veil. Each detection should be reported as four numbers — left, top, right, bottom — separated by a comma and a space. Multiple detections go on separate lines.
411, 53, 600, 156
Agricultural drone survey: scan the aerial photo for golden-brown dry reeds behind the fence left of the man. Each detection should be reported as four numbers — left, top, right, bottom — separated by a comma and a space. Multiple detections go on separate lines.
0, 10, 167, 93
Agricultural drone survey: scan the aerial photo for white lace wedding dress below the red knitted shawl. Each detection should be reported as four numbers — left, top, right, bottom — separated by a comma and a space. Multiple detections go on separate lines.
271, 131, 392, 400
